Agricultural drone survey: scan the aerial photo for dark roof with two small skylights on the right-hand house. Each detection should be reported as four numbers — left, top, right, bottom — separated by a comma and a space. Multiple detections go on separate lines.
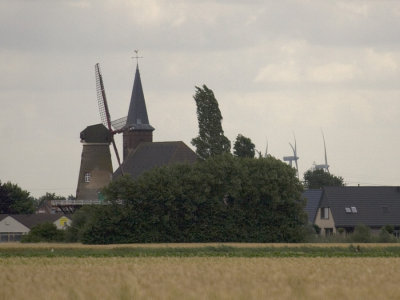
320, 186, 400, 227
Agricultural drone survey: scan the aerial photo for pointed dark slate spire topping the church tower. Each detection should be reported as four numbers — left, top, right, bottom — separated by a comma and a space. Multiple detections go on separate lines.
126, 67, 154, 130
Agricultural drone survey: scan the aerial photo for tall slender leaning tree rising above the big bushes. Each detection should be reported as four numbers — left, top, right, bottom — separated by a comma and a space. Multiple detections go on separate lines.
192, 85, 231, 159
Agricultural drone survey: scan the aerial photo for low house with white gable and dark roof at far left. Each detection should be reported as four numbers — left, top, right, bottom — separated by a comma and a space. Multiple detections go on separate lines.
0, 214, 72, 242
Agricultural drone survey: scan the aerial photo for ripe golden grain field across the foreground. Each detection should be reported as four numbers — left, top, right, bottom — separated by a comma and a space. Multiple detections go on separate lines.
0, 244, 400, 299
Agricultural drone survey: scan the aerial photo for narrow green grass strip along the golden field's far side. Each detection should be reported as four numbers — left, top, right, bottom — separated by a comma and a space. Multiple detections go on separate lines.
0, 245, 400, 258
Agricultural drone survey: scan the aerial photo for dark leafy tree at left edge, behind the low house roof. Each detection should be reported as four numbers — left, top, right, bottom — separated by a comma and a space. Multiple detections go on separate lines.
0, 182, 35, 214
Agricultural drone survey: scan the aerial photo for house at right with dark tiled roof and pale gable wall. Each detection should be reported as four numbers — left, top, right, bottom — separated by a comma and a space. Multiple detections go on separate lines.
310, 186, 400, 236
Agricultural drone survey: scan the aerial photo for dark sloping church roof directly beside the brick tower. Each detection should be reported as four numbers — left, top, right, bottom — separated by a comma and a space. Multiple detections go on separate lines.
113, 141, 197, 179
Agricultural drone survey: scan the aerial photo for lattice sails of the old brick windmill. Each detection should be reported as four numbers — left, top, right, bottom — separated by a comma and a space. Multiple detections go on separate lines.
95, 63, 126, 174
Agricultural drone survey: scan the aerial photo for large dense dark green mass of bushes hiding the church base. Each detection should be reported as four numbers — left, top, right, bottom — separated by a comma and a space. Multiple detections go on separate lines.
79, 154, 306, 243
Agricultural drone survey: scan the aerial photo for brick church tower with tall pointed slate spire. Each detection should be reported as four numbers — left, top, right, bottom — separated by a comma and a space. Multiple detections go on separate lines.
123, 65, 154, 160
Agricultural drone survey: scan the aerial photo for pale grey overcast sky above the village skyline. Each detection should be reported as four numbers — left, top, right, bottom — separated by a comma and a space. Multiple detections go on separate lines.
0, 0, 400, 197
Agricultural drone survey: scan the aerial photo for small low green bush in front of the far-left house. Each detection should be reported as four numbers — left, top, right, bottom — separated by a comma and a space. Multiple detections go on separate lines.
21, 222, 64, 243
